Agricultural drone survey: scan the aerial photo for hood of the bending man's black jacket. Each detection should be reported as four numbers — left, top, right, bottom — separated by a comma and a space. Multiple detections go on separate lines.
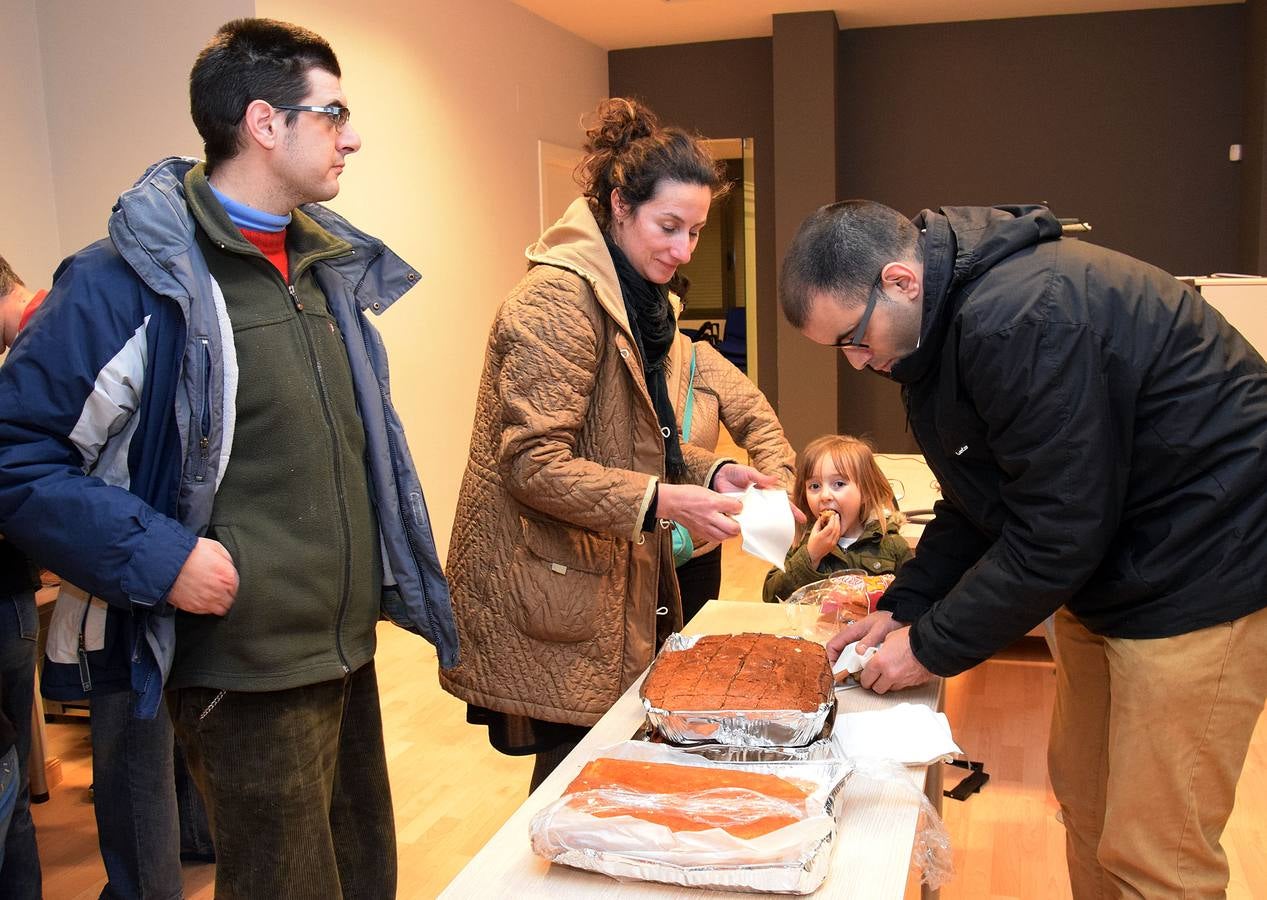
891, 204, 1060, 384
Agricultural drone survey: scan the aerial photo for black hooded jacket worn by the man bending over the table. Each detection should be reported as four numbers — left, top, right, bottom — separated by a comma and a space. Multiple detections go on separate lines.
881, 207, 1267, 676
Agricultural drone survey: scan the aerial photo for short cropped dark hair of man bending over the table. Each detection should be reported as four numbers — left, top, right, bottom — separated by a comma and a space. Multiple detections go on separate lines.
779, 200, 921, 328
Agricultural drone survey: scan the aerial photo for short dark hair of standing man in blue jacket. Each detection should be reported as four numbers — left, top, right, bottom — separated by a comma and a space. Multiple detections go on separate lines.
189, 19, 342, 172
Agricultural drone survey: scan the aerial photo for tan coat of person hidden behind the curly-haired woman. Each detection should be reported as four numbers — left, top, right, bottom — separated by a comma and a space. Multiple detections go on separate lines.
668, 331, 796, 556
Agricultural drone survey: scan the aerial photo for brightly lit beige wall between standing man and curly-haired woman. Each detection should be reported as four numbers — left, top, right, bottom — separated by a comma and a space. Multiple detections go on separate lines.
257, 0, 607, 554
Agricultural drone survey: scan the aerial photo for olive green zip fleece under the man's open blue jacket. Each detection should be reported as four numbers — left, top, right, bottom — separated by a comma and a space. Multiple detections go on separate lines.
169, 165, 381, 691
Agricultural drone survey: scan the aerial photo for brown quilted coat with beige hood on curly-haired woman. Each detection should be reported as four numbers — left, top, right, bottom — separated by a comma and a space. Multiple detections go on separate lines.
440, 200, 718, 725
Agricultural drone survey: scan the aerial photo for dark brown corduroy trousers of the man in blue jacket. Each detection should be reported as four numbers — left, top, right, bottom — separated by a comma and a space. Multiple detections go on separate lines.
167, 662, 397, 900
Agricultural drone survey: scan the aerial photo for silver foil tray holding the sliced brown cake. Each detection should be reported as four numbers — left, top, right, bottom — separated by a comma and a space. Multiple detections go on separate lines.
642, 634, 836, 747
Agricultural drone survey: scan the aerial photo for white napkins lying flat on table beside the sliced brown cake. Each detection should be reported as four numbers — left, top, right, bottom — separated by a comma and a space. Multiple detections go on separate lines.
831, 704, 963, 766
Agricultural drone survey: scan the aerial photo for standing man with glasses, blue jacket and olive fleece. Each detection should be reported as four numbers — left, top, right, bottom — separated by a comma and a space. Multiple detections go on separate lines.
0, 19, 457, 897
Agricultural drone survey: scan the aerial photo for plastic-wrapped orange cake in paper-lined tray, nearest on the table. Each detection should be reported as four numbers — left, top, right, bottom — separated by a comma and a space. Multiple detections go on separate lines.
530, 742, 851, 894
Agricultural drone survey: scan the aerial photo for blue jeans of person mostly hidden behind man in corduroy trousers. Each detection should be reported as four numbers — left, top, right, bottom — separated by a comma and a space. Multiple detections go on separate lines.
91, 691, 210, 900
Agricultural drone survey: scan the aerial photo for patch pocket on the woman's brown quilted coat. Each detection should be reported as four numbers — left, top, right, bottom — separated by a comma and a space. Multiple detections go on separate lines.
507, 516, 616, 644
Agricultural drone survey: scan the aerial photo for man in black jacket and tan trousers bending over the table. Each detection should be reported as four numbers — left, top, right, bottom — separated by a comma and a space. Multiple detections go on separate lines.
779, 200, 1267, 897
